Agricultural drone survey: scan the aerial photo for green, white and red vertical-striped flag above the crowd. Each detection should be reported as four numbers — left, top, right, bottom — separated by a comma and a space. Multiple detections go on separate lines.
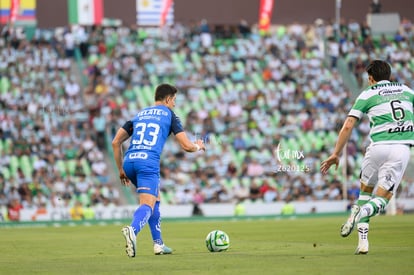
68, 0, 103, 25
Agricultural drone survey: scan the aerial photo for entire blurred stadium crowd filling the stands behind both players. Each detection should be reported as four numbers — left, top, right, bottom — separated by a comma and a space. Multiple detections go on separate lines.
0, 16, 414, 220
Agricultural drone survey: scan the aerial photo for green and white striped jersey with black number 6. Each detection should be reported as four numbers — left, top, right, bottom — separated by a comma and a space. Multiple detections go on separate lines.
348, 81, 414, 145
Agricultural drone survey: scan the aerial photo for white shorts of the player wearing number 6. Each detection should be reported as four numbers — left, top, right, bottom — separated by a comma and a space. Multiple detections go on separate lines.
361, 144, 410, 192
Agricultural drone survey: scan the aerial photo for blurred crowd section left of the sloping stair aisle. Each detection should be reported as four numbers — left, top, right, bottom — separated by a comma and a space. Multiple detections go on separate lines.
0, 25, 119, 220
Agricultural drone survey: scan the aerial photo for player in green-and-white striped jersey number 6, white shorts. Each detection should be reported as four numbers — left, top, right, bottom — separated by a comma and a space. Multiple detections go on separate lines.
321, 60, 414, 254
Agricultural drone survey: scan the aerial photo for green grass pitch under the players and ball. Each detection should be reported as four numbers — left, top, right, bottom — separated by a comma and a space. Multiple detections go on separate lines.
0, 215, 414, 275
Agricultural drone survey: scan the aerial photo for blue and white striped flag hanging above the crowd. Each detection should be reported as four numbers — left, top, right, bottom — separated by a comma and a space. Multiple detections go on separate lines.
137, 0, 174, 26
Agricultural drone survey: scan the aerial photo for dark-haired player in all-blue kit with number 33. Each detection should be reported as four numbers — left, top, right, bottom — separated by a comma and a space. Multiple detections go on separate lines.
112, 84, 205, 257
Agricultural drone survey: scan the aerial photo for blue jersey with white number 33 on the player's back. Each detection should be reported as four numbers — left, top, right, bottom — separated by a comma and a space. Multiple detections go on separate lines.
122, 105, 184, 166
